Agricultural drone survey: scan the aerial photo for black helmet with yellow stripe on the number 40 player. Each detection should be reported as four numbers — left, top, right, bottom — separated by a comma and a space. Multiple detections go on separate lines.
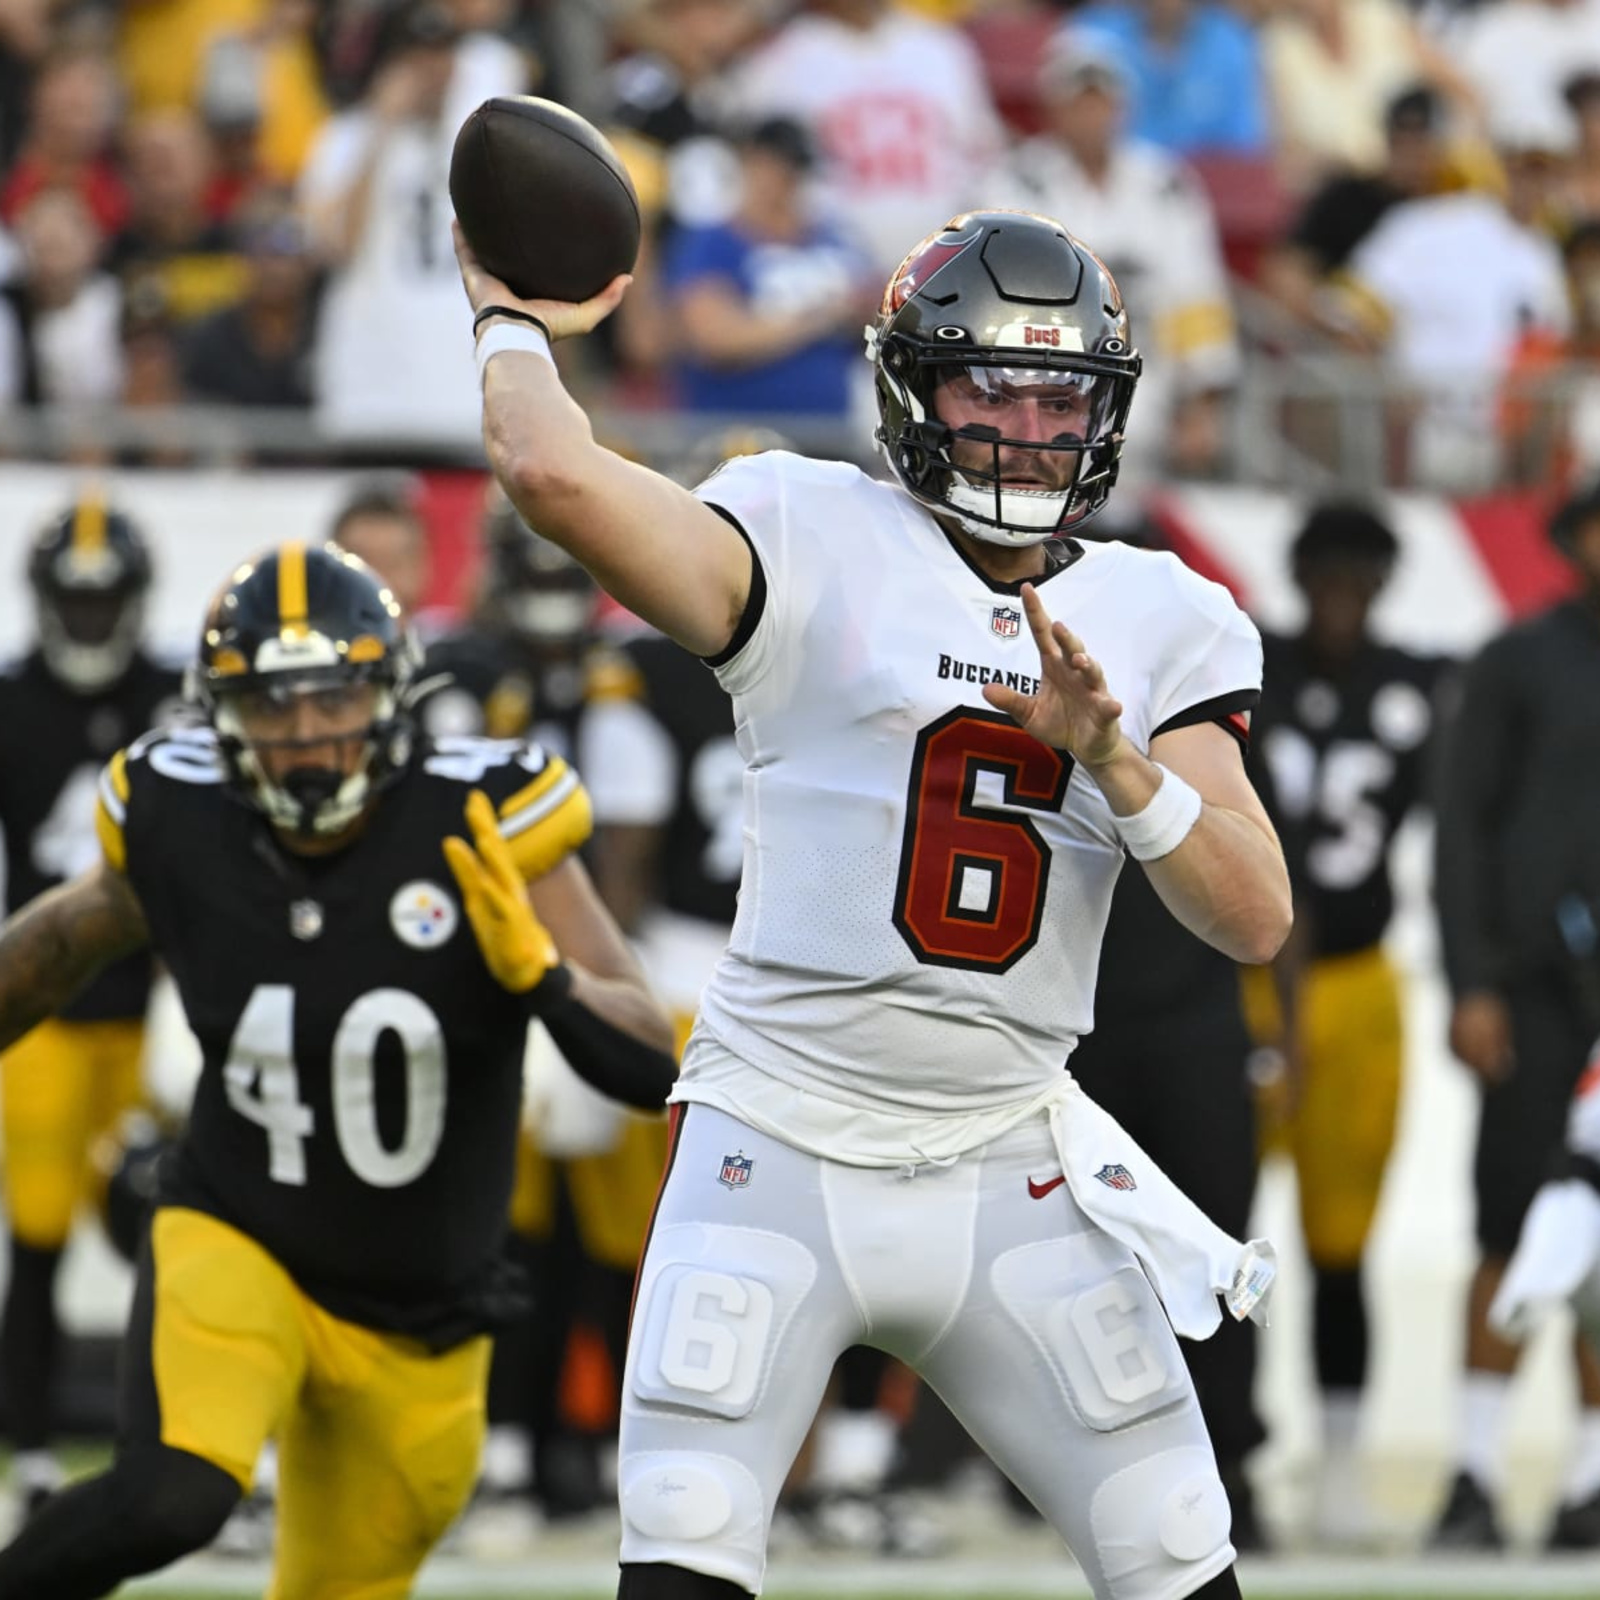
192, 541, 419, 835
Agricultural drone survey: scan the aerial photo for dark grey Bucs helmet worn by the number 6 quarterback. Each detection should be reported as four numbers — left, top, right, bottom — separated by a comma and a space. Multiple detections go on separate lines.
867, 211, 1141, 547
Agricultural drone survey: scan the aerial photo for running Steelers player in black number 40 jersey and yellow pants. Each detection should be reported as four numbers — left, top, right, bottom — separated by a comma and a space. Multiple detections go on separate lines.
0, 542, 674, 1600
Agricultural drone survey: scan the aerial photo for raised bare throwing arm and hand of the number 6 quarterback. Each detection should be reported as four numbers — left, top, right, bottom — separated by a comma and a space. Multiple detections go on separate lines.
456, 227, 752, 656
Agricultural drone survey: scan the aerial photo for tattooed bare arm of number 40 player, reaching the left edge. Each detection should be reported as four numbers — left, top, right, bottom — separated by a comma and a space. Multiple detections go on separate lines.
0, 862, 150, 1050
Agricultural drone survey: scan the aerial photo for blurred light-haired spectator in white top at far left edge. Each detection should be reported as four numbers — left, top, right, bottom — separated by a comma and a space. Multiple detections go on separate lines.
3, 189, 122, 405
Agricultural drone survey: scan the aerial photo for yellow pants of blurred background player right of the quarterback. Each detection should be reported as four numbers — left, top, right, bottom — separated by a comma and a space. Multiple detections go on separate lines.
1243, 946, 1403, 1270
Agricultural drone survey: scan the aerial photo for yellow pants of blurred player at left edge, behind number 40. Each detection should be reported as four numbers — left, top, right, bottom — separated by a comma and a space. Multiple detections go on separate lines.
0, 1019, 144, 1250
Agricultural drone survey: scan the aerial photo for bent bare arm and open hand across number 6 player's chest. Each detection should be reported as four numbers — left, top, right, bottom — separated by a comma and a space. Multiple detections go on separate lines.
984, 584, 1293, 963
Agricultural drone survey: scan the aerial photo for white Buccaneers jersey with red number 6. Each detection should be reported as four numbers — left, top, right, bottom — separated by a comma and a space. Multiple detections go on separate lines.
678, 451, 1261, 1118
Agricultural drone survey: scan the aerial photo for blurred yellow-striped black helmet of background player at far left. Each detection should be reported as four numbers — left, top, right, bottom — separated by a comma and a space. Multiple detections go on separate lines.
27, 493, 150, 694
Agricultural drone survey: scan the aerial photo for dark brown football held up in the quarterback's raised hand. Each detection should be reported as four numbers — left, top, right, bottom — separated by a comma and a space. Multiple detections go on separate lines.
450, 94, 638, 301
